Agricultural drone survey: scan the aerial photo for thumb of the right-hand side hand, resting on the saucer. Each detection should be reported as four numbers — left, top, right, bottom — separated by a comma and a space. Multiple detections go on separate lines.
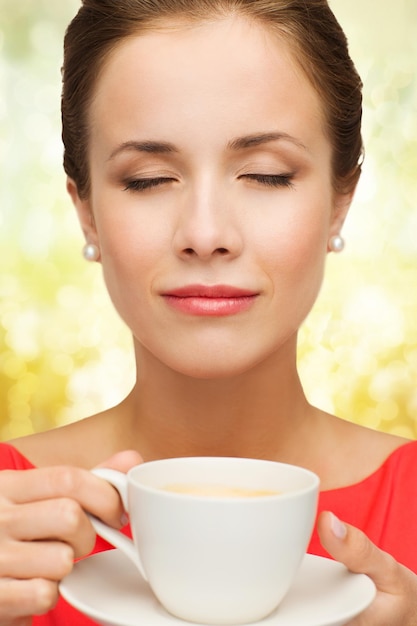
317, 511, 405, 593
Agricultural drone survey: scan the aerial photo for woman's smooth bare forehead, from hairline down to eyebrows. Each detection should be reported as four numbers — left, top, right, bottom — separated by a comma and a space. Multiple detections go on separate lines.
91, 17, 324, 152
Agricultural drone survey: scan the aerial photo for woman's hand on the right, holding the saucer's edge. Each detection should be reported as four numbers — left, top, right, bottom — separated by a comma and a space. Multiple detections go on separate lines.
318, 511, 417, 626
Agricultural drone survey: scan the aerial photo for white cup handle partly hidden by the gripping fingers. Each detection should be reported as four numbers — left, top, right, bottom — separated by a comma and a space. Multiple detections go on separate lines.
87, 467, 148, 581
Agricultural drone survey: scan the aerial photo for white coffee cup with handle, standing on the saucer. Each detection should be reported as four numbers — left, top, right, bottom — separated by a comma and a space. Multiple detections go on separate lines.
92, 457, 319, 625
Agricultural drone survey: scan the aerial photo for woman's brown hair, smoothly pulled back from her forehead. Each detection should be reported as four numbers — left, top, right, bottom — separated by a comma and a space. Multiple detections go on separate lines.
62, 0, 363, 198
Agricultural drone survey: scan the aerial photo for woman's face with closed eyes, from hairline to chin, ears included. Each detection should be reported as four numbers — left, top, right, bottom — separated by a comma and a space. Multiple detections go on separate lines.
69, 18, 346, 378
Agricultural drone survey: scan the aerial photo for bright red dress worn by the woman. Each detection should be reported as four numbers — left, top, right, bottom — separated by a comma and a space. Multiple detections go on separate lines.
0, 441, 417, 626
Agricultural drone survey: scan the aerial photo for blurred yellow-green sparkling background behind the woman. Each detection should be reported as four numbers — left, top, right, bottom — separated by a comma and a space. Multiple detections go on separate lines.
0, 0, 417, 440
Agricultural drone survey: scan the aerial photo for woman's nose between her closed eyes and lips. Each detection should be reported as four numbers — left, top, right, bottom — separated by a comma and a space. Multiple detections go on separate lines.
173, 183, 243, 261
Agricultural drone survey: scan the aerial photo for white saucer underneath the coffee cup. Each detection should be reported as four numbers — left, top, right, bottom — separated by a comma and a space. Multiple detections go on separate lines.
60, 550, 375, 626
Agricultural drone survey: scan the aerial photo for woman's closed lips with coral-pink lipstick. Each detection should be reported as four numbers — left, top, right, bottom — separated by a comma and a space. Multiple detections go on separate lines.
162, 285, 259, 317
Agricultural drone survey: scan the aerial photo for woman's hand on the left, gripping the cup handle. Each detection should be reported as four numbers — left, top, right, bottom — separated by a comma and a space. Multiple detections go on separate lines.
0, 451, 141, 626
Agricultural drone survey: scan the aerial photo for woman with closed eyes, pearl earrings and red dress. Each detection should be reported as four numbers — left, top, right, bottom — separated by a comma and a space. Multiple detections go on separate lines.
0, 0, 417, 626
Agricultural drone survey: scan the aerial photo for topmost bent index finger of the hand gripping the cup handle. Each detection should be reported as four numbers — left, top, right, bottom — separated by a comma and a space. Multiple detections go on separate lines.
0, 466, 123, 528
